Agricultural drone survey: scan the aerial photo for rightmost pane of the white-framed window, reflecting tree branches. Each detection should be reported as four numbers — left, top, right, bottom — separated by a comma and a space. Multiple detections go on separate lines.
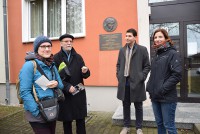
66, 0, 83, 34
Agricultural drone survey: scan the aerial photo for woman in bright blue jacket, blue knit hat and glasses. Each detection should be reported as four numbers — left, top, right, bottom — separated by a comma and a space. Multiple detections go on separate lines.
19, 36, 63, 134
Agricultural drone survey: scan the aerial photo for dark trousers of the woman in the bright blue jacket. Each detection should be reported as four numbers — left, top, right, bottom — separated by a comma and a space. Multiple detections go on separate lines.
29, 121, 56, 134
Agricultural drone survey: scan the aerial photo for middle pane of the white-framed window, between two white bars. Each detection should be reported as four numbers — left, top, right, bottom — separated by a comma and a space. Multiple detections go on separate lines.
47, 0, 62, 37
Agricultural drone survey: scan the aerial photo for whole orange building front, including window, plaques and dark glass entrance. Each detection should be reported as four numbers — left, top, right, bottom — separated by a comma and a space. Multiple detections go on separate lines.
0, 0, 200, 111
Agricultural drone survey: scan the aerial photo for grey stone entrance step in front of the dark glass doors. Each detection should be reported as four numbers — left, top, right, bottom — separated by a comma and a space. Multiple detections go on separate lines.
112, 103, 200, 130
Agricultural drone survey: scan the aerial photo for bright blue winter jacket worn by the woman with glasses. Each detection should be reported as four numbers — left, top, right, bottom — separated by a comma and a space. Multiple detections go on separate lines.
19, 59, 64, 117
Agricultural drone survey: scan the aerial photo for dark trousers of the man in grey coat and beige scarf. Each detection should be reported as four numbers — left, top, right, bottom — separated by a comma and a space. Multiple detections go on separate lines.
123, 85, 143, 129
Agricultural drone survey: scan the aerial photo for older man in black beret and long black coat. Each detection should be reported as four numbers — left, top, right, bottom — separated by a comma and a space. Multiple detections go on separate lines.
54, 34, 90, 134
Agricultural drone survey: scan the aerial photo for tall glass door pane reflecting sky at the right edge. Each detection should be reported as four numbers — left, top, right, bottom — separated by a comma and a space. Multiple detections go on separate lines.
187, 24, 200, 97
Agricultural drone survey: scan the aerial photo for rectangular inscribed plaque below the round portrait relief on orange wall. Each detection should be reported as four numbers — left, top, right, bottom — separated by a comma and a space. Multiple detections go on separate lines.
99, 33, 122, 51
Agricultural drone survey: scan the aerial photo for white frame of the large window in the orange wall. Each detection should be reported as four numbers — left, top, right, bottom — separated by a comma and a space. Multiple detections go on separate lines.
22, 0, 86, 43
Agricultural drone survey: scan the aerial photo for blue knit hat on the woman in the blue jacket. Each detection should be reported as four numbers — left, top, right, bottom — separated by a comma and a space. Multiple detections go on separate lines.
33, 35, 52, 53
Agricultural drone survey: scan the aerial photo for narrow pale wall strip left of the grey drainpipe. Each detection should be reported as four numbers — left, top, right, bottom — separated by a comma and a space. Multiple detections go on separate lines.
0, 0, 6, 82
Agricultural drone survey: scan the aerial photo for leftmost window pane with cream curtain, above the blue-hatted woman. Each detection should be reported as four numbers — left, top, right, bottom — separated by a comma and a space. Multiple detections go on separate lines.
30, 0, 43, 38
